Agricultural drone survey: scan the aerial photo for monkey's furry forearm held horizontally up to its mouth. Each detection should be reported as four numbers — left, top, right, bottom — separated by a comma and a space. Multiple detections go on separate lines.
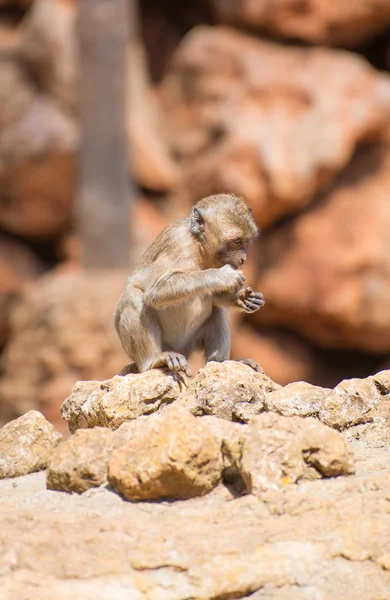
144, 265, 245, 309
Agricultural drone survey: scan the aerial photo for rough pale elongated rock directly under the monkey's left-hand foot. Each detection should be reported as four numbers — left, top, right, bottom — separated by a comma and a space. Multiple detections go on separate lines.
61, 369, 180, 433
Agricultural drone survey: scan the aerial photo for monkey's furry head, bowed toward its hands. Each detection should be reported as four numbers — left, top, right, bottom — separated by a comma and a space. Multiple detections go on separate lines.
190, 194, 259, 269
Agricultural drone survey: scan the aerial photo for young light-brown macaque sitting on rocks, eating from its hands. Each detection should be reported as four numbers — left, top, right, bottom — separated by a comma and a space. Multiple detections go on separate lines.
115, 194, 264, 375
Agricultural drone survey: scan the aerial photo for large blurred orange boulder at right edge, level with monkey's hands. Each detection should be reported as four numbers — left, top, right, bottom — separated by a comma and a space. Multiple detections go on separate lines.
253, 144, 390, 353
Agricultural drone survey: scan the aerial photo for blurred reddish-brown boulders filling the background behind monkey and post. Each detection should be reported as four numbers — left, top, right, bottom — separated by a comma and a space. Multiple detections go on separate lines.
0, 0, 390, 434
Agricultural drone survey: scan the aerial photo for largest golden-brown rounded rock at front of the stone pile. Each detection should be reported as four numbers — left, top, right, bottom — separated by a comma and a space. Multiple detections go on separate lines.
109, 409, 222, 500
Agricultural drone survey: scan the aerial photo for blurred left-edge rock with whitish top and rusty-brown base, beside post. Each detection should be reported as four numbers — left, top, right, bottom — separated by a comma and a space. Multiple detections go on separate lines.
0, 96, 78, 239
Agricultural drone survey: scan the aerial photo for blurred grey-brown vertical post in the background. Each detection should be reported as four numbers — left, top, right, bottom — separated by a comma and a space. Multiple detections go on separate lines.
77, 0, 130, 269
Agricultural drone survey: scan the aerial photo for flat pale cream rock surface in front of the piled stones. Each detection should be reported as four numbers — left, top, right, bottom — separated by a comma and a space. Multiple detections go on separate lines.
0, 434, 390, 600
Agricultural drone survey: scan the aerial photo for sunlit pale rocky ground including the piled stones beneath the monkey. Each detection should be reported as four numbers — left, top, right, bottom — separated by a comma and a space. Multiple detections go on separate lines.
0, 362, 390, 600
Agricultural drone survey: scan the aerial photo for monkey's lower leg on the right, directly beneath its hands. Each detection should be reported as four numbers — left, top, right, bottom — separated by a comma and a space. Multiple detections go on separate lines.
201, 306, 230, 362
